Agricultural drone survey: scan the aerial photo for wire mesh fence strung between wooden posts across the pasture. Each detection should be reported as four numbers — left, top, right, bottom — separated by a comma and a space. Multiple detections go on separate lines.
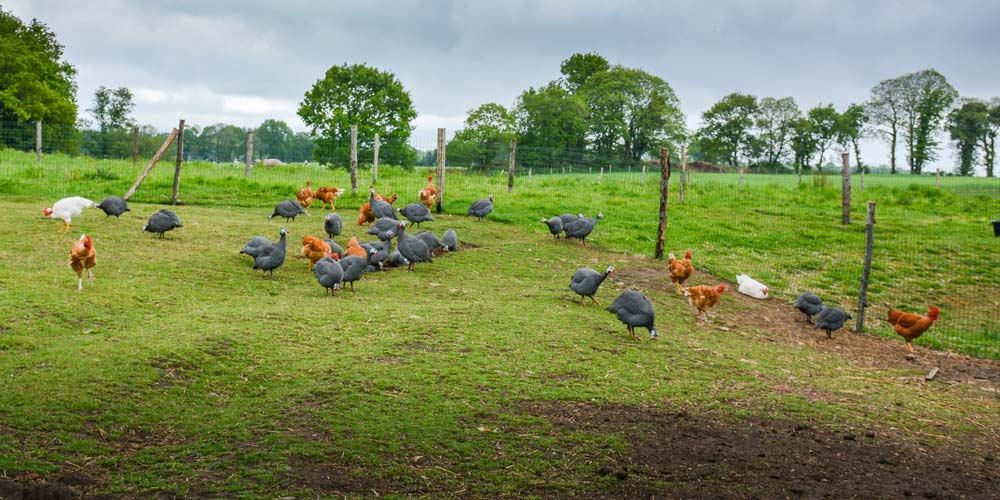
0, 121, 1000, 359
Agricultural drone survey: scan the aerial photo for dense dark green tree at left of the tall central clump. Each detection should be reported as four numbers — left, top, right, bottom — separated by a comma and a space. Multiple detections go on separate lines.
513, 82, 589, 166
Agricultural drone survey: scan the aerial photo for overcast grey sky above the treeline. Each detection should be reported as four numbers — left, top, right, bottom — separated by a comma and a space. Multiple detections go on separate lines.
7, 0, 1000, 170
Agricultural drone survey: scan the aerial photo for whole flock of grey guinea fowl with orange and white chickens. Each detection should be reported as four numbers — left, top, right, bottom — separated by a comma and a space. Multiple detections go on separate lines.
43, 177, 939, 352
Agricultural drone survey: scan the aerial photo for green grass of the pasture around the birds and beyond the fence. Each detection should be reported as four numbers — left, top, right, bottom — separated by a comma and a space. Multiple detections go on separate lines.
0, 152, 1000, 498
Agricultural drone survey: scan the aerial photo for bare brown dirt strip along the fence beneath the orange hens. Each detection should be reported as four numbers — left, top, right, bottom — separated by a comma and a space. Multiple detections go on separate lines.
615, 257, 1000, 390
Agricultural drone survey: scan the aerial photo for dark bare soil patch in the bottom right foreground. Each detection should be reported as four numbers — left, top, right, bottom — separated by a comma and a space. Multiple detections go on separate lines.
519, 401, 1000, 498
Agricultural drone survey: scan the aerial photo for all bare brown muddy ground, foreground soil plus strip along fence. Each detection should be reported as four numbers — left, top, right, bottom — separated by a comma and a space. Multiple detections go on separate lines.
0, 264, 1000, 499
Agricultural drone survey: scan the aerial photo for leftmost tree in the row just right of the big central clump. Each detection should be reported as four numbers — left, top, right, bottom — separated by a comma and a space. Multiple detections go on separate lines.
697, 92, 759, 166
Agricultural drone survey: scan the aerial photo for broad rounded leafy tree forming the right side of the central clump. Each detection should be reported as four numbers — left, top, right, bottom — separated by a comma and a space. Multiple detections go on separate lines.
579, 66, 684, 164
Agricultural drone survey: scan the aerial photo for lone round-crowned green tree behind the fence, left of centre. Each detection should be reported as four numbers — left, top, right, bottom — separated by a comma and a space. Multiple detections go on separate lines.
298, 64, 417, 168
